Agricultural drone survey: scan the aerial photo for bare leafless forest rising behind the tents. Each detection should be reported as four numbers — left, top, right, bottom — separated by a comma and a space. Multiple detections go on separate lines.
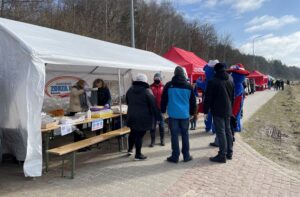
0, 0, 300, 80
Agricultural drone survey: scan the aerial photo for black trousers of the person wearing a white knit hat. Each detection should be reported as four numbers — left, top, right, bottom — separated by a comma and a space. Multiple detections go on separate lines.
128, 129, 146, 156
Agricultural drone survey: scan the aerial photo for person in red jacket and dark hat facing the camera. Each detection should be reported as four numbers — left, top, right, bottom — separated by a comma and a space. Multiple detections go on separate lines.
149, 73, 165, 147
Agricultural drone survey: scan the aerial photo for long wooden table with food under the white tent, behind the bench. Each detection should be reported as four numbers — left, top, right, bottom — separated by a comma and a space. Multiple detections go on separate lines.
41, 114, 126, 172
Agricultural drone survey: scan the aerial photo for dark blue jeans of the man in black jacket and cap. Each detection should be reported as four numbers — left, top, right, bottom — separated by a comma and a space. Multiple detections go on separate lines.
213, 116, 233, 157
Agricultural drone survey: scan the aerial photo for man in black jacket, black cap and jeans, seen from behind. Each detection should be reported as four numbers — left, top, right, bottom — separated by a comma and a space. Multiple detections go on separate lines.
204, 63, 234, 163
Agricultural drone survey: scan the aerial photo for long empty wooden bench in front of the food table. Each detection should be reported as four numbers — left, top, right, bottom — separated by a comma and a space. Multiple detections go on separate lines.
47, 127, 130, 179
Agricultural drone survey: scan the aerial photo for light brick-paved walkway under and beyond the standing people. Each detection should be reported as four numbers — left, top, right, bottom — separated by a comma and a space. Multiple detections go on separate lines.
0, 91, 300, 197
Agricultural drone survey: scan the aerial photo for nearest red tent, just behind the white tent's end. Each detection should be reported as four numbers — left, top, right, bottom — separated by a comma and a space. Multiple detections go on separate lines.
163, 47, 207, 81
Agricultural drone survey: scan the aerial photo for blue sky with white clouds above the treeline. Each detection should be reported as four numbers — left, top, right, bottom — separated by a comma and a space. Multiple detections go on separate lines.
149, 0, 300, 67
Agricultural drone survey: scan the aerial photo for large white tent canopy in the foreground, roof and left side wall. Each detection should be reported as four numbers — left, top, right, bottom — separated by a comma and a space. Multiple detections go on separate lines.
0, 18, 177, 177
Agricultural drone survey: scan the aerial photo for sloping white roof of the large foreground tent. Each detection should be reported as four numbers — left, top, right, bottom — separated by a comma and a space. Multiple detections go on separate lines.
0, 18, 177, 73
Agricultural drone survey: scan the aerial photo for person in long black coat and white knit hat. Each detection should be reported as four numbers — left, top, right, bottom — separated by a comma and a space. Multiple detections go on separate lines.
126, 74, 162, 160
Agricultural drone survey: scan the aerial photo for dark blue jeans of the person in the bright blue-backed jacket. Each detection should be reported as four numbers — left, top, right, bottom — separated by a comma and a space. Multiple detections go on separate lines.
169, 118, 190, 160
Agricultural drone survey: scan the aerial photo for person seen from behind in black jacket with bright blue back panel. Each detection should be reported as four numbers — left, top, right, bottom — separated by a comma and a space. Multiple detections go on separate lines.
161, 66, 197, 163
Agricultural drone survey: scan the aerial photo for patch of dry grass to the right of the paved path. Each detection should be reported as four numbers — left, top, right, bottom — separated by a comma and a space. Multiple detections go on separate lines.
242, 85, 300, 174
